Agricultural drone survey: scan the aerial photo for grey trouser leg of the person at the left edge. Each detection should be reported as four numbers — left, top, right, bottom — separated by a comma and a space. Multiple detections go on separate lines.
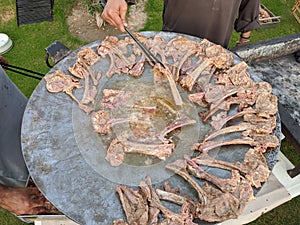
0, 66, 29, 187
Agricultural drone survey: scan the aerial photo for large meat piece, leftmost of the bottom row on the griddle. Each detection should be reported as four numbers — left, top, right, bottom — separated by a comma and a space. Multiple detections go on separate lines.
115, 186, 149, 225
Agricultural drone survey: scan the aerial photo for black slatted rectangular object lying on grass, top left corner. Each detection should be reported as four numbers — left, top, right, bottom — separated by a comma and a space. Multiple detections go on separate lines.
16, 0, 54, 26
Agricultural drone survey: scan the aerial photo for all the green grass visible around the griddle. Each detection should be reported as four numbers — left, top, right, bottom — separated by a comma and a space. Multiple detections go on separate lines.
0, 0, 300, 225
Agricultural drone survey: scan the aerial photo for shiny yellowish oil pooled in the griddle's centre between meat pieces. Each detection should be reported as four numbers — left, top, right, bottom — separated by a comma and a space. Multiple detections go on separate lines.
99, 74, 197, 166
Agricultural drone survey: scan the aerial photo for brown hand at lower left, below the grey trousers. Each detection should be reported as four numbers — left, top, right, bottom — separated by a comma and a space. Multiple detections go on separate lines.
0, 185, 50, 215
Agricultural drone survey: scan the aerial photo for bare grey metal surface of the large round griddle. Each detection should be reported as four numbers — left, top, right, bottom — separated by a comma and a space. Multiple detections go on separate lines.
22, 32, 281, 225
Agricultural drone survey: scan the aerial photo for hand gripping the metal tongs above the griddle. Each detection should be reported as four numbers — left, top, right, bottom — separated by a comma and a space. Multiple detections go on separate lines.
101, 0, 128, 33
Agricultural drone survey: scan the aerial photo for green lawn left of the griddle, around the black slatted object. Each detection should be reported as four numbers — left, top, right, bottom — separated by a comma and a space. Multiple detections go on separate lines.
0, 0, 84, 97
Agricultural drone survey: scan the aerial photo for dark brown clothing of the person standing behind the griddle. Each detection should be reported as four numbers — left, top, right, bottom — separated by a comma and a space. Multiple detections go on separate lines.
162, 0, 259, 47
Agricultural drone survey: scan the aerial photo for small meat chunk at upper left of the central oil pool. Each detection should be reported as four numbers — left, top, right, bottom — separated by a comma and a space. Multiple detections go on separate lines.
101, 89, 132, 109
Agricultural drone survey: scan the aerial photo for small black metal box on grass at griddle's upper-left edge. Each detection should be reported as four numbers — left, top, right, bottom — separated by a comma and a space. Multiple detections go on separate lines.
45, 41, 72, 68
